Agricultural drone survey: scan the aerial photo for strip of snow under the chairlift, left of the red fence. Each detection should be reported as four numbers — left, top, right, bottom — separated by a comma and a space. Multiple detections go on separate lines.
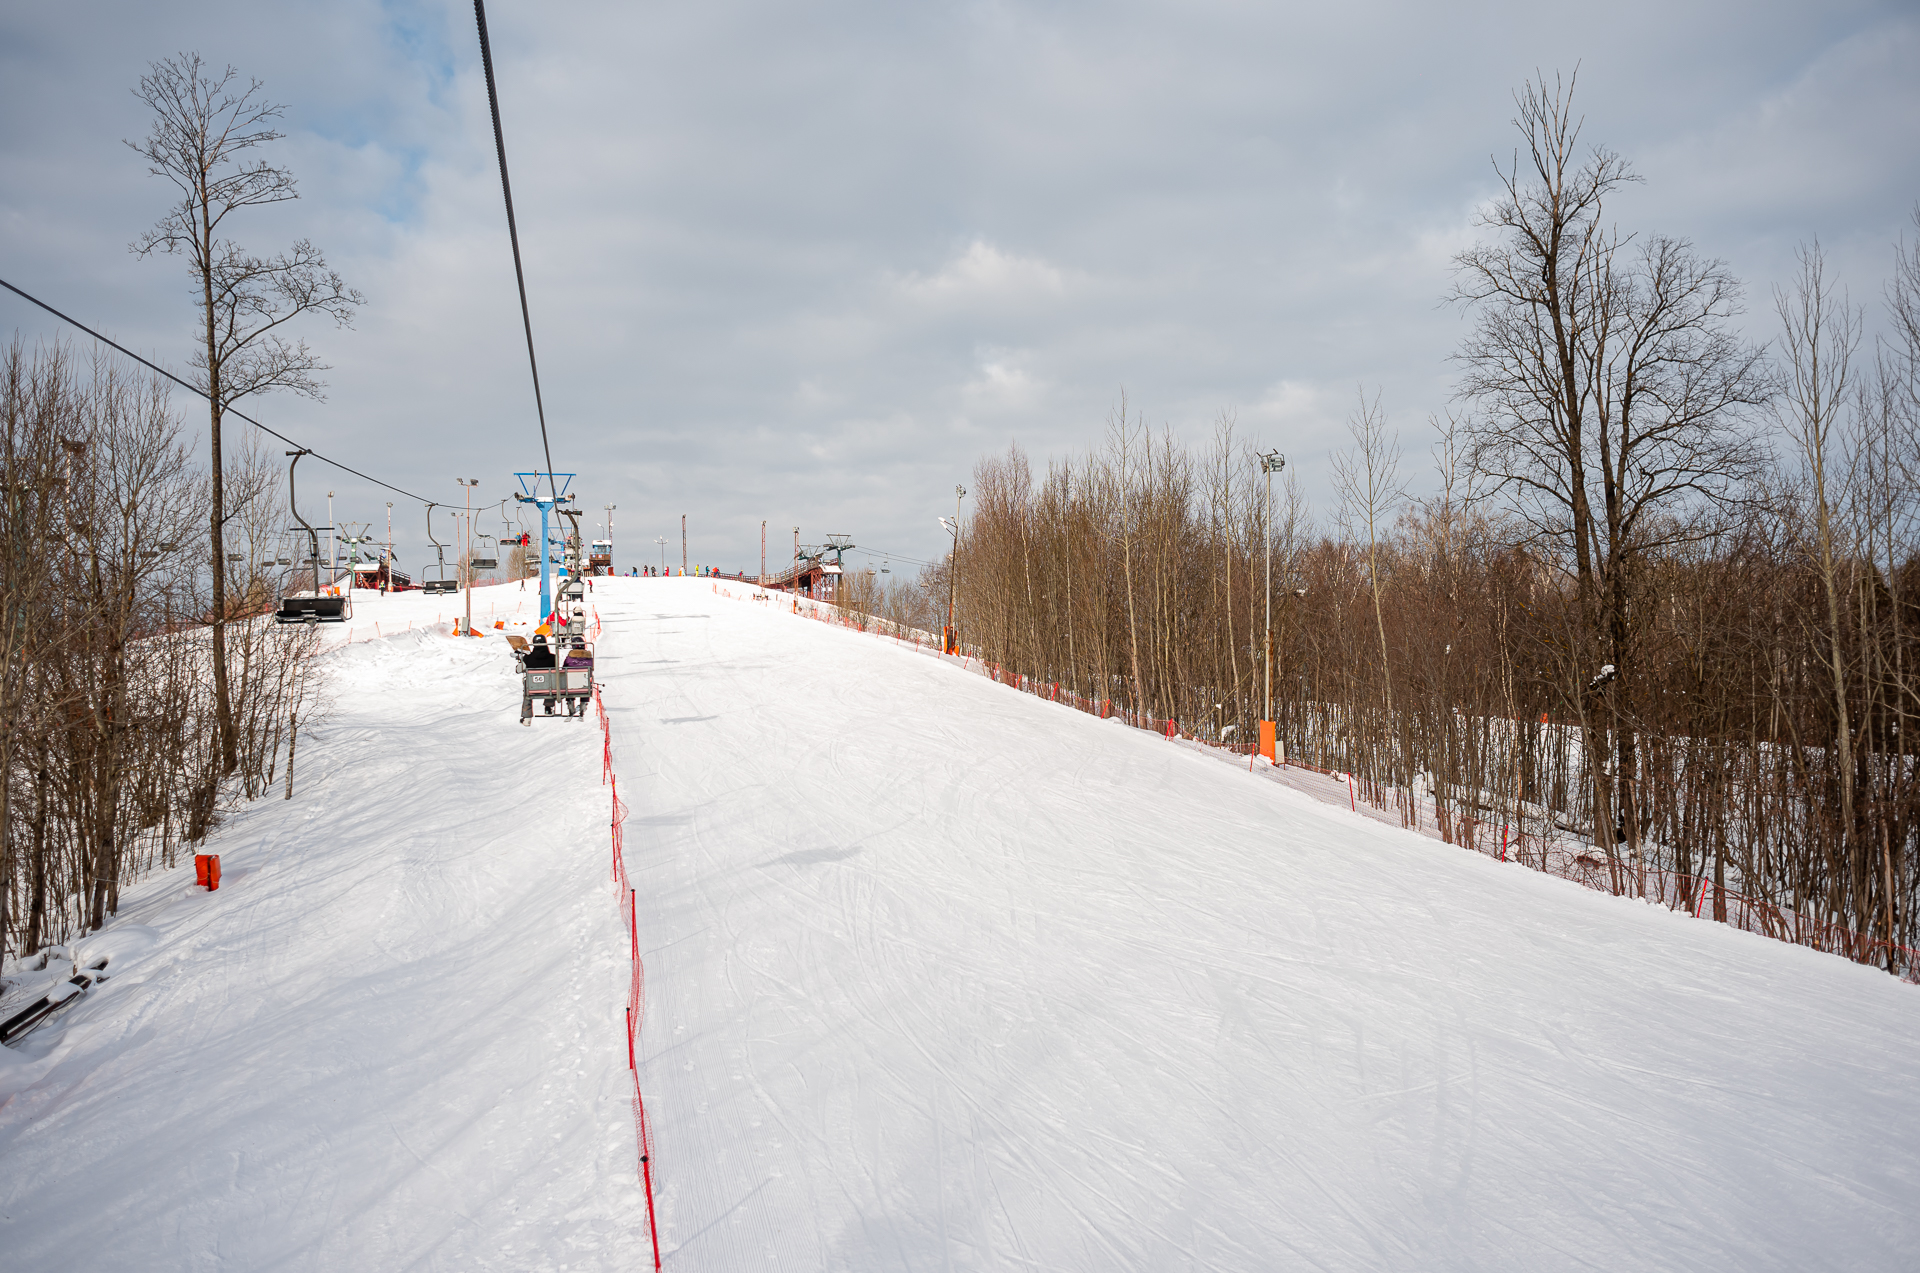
0, 597, 645, 1269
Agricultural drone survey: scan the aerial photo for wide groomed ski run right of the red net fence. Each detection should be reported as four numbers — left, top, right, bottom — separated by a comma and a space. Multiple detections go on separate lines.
601, 580, 1920, 1269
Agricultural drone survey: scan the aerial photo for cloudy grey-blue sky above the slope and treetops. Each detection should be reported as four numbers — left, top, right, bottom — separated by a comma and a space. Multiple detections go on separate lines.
0, 0, 1920, 570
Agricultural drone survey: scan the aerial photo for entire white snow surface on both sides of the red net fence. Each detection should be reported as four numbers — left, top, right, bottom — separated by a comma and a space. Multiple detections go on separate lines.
0, 580, 1920, 1273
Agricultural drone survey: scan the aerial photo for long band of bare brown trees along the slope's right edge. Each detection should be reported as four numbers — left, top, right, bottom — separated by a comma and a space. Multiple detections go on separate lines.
879, 84, 1920, 966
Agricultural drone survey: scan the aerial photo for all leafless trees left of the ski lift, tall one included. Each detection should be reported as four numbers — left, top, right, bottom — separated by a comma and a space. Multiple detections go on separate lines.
0, 54, 363, 956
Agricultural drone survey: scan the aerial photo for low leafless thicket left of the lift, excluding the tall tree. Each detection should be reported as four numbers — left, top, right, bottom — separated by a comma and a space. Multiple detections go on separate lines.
0, 340, 321, 954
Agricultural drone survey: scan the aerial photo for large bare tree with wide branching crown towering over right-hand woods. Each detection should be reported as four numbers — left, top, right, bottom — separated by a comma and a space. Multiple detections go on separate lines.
1453, 72, 1772, 875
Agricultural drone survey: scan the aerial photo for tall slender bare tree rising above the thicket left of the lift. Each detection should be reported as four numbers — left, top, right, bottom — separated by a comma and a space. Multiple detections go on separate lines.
127, 54, 363, 772
